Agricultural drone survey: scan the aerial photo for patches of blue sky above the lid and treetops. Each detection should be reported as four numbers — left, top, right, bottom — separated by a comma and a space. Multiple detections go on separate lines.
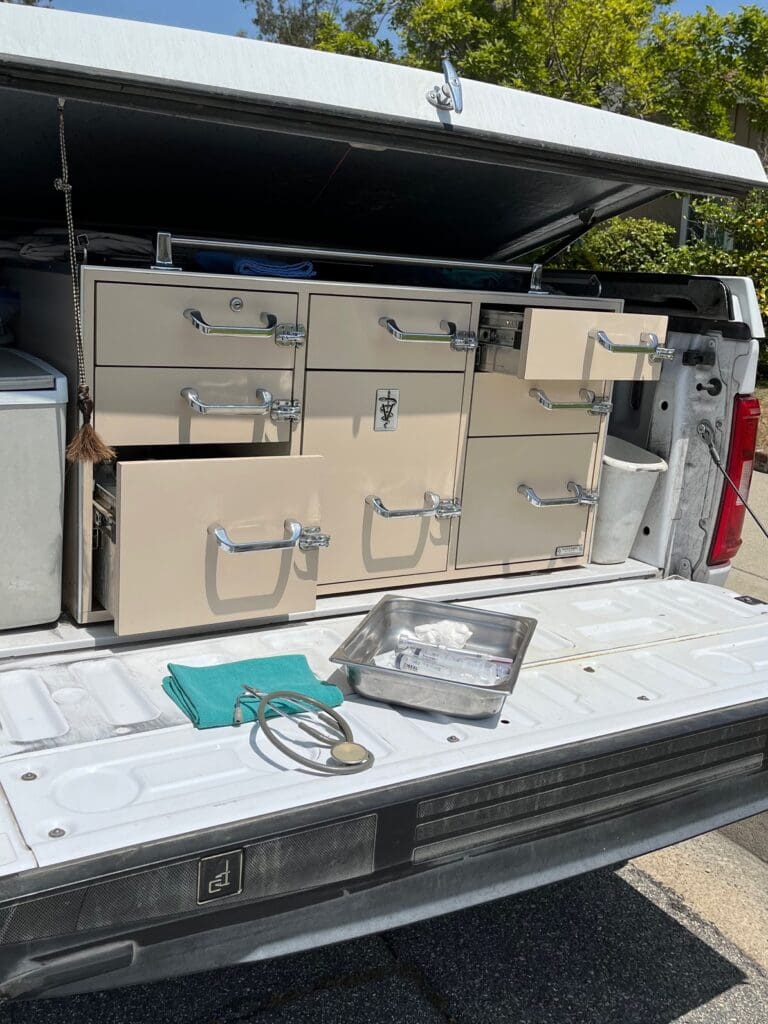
48, 0, 754, 35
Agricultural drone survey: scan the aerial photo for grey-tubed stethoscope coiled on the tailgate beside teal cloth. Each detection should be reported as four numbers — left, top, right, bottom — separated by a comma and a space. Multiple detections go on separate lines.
232, 686, 374, 775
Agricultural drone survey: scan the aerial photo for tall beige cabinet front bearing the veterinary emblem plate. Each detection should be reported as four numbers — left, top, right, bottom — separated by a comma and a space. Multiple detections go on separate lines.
303, 371, 464, 583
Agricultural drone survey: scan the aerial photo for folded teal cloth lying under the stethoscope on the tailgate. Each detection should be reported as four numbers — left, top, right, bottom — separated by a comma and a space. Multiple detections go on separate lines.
163, 654, 344, 729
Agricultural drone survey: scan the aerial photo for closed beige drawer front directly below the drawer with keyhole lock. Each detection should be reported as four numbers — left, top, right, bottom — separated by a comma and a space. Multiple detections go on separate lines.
94, 367, 293, 445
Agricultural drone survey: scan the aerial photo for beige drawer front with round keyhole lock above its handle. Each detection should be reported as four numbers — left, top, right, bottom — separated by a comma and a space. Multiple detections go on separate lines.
95, 281, 298, 369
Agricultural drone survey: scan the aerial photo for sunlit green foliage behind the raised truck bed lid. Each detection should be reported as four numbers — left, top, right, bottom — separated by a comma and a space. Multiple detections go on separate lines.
243, 0, 768, 375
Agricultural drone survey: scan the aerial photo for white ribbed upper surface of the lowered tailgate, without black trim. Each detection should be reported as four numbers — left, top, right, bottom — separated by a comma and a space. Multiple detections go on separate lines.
0, 580, 768, 869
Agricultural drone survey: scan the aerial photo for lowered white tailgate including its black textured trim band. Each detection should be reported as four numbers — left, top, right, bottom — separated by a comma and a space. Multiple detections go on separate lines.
0, 574, 768, 995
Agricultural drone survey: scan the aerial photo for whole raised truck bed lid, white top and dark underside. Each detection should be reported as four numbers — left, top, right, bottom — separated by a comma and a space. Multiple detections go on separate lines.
0, 4, 767, 260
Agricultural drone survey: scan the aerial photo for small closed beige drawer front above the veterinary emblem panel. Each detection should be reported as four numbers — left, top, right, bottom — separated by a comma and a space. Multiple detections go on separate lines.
307, 295, 472, 372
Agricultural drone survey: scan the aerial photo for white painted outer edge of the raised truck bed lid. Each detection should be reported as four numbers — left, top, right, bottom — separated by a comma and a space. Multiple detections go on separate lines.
0, 4, 766, 192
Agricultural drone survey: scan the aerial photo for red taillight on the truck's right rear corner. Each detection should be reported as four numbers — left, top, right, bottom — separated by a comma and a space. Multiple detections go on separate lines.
708, 394, 760, 565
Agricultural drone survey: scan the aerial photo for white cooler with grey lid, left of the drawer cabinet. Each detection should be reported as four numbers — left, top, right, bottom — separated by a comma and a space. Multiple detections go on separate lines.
0, 348, 67, 630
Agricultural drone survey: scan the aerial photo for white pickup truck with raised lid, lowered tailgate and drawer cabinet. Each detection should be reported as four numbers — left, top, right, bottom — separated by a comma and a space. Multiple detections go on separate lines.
0, 5, 768, 998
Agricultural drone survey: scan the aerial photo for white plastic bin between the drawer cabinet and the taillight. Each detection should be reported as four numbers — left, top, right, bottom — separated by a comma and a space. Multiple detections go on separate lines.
592, 436, 667, 565
